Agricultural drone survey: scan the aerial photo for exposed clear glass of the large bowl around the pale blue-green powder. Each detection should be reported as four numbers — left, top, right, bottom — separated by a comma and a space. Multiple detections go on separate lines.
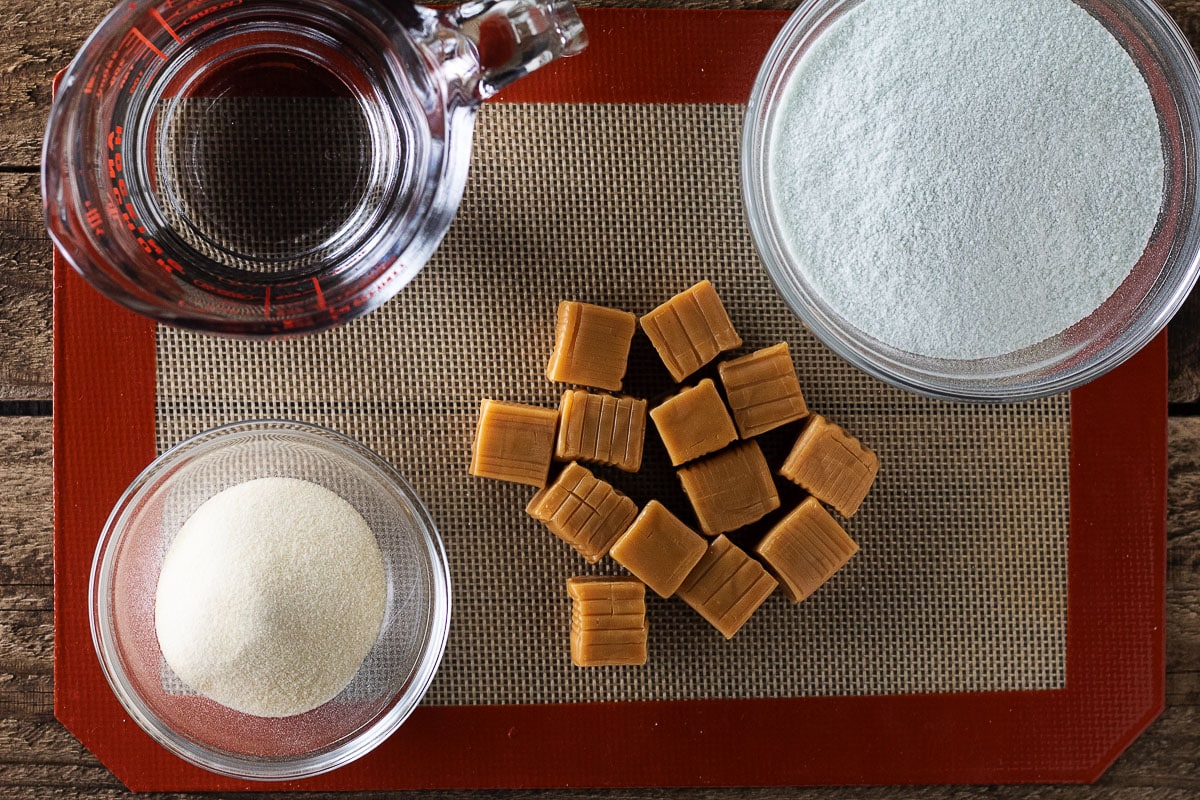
742, 0, 1200, 402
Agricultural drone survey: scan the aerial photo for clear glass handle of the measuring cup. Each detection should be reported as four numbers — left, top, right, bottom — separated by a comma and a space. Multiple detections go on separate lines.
440, 0, 588, 100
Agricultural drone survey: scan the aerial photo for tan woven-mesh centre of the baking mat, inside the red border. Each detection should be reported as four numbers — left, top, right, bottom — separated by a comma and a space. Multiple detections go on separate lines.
156, 104, 1070, 704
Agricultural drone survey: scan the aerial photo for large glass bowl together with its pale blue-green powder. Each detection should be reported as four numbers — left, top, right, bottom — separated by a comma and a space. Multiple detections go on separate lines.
743, 0, 1200, 401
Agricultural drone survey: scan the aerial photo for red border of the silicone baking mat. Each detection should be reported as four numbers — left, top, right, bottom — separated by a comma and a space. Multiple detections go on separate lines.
54, 10, 1166, 790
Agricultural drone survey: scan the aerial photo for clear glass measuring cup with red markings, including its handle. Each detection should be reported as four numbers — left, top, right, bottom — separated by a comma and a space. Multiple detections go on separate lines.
42, 0, 587, 337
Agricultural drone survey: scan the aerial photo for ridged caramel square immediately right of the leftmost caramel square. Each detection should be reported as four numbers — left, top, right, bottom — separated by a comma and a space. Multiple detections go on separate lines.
554, 389, 646, 473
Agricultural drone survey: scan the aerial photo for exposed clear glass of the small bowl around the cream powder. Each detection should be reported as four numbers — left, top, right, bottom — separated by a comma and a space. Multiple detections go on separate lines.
89, 421, 450, 781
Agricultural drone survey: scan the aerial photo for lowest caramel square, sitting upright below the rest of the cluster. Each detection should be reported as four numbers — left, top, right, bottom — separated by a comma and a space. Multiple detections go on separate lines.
566, 577, 647, 667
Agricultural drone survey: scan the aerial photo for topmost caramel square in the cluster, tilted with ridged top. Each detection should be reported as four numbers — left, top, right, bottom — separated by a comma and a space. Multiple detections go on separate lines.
641, 281, 742, 381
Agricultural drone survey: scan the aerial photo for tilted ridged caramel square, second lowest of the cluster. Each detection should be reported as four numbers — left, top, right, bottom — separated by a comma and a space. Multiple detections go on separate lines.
678, 536, 778, 639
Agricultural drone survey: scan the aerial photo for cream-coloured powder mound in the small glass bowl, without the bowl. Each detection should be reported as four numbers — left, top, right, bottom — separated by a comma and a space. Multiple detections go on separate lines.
155, 477, 388, 717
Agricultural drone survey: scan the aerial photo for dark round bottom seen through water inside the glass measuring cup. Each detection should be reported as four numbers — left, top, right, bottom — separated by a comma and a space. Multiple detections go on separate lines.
154, 53, 380, 273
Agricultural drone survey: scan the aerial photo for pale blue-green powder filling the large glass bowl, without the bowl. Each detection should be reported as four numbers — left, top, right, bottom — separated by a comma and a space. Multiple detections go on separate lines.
767, 0, 1164, 359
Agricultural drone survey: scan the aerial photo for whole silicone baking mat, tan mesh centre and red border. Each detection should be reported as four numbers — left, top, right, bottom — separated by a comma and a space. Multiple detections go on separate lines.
55, 11, 1165, 790
